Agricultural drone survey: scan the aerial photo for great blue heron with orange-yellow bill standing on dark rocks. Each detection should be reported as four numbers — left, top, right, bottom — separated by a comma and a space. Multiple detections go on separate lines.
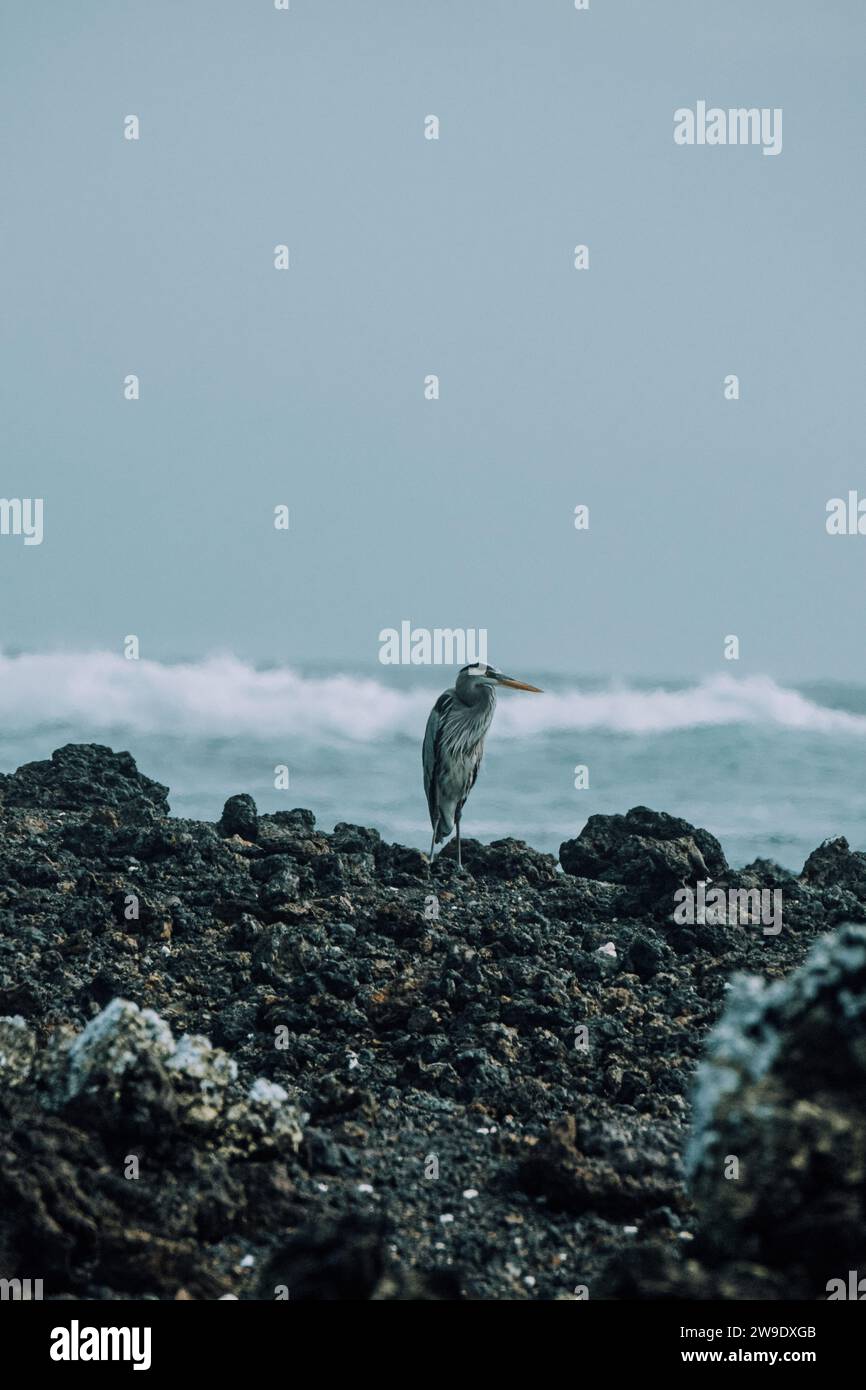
423, 663, 541, 867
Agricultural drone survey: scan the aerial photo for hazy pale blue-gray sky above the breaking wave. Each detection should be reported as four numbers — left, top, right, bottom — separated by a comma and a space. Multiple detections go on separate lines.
0, 0, 866, 680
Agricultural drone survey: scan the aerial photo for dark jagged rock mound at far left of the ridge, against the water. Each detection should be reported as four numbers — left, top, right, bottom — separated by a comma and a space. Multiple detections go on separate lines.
0, 744, 168, 820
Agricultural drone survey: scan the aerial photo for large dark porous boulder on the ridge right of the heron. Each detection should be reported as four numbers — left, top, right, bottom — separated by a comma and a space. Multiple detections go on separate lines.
559, 806, 727, 902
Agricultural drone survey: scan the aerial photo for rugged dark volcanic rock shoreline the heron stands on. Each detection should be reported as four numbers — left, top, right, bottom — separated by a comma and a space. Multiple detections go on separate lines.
0, 745, 866, 1300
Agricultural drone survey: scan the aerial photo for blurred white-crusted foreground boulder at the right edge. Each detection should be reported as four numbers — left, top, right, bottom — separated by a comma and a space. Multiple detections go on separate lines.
688, 926, 866, 1298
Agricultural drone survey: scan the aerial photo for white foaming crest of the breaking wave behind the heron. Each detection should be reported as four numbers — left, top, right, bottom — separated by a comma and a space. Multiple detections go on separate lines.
0, 652, 866, 744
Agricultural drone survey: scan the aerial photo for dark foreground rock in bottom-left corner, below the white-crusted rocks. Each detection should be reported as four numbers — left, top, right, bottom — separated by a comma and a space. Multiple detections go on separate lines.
0, 1097, 297, 1300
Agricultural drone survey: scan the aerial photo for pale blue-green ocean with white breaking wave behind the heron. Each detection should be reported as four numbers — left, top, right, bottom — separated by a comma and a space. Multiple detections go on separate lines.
0, 652, 866, 870
